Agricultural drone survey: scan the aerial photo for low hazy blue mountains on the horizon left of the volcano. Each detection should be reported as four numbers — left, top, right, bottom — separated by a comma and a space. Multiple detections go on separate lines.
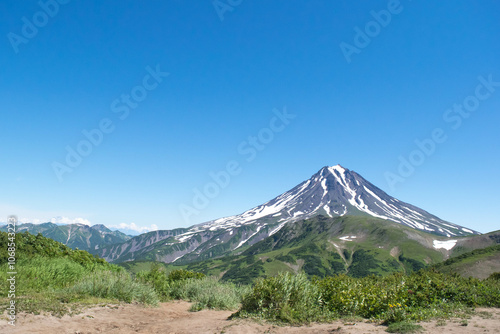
0, 223, 131, 252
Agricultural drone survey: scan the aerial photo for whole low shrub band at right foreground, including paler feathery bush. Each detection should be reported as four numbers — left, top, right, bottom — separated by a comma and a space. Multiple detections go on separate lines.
235, 271, 500, 324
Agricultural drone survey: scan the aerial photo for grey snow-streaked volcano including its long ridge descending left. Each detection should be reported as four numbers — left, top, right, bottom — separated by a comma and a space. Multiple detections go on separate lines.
94, 165, 479, 263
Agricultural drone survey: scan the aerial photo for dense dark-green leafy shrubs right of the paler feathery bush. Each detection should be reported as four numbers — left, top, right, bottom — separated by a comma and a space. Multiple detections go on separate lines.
316, 271, 500, 323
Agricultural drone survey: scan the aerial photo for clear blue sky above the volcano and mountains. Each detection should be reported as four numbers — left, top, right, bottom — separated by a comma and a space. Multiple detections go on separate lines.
0, 0, 500, 232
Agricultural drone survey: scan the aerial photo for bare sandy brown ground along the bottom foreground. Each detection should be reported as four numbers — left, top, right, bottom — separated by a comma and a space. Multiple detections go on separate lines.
0, 301, 500, 334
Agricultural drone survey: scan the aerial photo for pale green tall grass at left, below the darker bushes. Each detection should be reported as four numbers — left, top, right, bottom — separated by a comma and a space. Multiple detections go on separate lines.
0, 257, 159, 313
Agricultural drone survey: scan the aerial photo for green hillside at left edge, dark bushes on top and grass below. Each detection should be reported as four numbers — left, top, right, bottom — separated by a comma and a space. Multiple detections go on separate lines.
0, 232, 158, 315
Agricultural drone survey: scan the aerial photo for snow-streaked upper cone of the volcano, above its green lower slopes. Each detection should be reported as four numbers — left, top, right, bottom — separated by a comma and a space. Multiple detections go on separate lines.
197, 165, 474, 236
